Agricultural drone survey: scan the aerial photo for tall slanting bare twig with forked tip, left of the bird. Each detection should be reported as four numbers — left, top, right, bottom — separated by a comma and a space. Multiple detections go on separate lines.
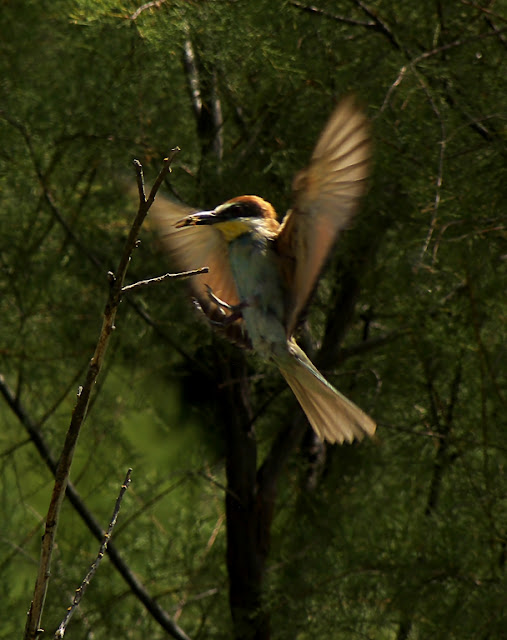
24, 149, 182, 640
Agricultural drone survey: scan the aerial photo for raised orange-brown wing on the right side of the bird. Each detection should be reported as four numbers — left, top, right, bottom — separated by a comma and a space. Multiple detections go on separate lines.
277, 97, 370, 336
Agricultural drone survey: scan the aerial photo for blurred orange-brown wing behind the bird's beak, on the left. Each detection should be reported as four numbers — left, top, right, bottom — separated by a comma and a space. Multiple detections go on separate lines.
149, 194, 248, 346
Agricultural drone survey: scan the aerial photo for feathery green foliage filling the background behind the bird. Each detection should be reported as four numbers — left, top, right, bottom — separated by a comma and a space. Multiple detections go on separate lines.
0, 0, 507, 640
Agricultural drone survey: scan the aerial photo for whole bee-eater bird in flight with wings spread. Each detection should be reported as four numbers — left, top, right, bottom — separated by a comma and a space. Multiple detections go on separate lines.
150, 97, 375, 443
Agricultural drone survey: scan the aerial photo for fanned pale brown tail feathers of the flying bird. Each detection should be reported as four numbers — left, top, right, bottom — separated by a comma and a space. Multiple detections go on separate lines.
275, 342, 376, 444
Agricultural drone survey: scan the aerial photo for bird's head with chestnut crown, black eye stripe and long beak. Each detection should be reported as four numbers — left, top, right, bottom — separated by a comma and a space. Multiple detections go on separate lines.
176, 196, 279, 242
